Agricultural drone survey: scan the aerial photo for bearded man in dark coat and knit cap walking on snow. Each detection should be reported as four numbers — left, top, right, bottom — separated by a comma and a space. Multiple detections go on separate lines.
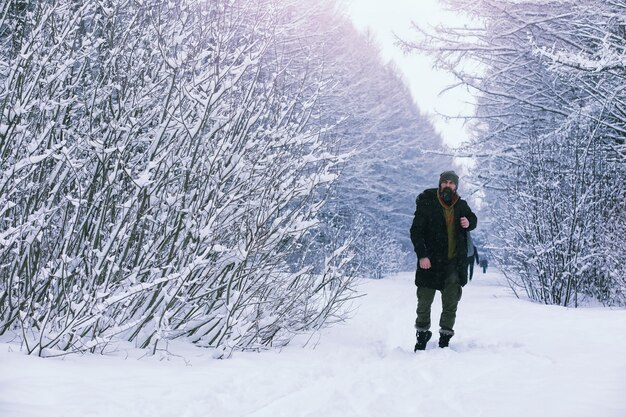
411, 171, 478, 351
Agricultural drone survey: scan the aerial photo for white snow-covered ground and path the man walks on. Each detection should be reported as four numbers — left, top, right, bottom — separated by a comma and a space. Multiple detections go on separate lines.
0, 271, 626, 417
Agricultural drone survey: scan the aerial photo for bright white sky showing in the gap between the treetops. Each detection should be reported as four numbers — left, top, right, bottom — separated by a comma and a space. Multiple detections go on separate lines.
344, 0, 474, 146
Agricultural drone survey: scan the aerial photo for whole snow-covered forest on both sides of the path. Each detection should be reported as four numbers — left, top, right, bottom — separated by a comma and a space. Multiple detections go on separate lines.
0, 0, 626, 357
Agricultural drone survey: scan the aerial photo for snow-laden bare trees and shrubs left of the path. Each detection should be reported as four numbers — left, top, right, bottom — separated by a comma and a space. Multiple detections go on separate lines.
0, 0, 448, 356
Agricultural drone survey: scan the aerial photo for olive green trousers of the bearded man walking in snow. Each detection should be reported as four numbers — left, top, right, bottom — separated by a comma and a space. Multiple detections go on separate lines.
415, 266, 463, 334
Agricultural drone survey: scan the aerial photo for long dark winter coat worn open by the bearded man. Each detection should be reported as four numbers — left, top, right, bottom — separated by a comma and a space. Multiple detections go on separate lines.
411, 188, 478, 290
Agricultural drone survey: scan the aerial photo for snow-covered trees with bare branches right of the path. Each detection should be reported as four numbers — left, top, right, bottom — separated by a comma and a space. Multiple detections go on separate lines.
405, 0, 626, 306
